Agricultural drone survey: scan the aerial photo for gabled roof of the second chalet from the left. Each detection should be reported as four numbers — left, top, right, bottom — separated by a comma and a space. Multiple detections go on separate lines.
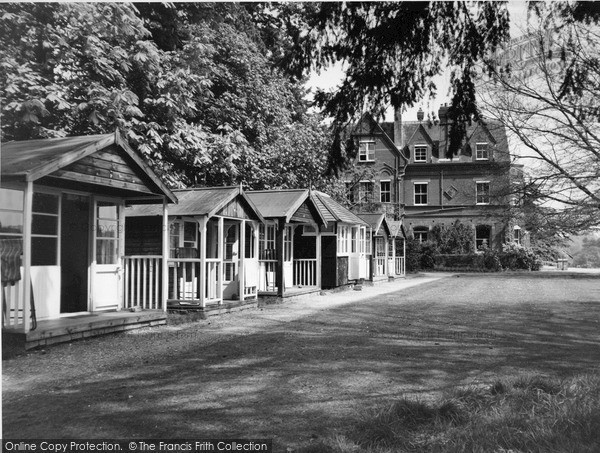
125, 186, 265, 222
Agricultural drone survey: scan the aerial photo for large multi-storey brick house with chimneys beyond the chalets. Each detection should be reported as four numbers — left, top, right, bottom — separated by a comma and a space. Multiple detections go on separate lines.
344, 106, 527, 249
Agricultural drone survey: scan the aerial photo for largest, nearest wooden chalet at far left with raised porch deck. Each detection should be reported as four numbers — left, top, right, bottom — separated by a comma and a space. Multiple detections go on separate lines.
0, 133, 177, 348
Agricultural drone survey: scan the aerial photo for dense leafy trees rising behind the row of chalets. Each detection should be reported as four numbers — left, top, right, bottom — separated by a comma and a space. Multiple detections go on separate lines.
0, 3, 328, 188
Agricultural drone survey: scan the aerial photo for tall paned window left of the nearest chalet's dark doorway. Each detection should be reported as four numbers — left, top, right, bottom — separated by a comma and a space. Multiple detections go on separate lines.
31, 192, 59, 266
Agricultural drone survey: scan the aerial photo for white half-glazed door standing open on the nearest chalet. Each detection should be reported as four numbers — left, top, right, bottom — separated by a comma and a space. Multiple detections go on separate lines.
92, 199, 125, 311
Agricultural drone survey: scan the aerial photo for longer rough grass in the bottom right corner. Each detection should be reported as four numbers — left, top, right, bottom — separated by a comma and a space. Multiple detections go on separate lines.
299, 374, 600, 453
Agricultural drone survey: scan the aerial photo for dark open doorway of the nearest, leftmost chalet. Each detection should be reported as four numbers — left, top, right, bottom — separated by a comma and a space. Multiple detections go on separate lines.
60, 194, 91, 313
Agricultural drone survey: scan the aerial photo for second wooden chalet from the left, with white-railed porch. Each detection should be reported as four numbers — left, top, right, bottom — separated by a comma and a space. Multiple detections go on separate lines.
125, 187, 264, 314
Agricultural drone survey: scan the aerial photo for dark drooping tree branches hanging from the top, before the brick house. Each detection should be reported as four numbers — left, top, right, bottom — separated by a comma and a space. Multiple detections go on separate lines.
272, 1, 508, 173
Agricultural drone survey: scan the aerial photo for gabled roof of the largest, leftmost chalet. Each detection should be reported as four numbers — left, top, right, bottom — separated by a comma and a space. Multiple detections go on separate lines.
0, 132, 177, 202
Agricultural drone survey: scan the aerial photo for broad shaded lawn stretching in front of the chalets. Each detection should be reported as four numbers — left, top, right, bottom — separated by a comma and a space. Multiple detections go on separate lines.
3, 273, 600, 451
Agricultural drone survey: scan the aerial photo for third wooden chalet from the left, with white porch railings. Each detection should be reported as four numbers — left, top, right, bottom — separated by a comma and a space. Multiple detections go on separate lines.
247, 189, 327, 297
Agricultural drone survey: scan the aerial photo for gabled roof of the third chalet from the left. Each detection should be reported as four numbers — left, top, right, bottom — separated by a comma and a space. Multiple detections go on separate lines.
246, 189, 327, 225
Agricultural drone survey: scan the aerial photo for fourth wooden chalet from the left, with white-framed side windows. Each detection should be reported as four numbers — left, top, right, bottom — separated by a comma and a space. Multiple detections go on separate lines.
312, 191, 370, 288
